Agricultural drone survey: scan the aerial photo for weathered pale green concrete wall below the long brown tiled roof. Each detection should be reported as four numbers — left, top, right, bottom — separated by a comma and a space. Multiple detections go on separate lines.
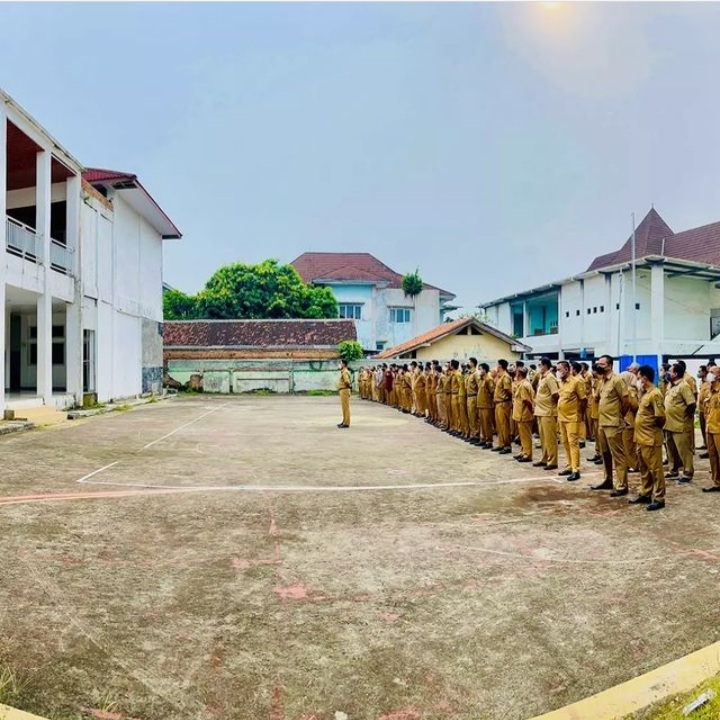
167, 359, 356, 393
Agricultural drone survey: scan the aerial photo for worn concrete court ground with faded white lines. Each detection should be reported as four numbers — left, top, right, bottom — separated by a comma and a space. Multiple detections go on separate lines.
0, 396, 720, 720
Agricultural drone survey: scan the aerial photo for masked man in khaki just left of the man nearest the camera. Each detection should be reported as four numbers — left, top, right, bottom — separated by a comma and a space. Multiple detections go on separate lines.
592, 355, 630, 497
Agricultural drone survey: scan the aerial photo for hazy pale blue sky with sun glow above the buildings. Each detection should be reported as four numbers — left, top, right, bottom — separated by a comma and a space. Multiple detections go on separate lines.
0, 2, 720, 310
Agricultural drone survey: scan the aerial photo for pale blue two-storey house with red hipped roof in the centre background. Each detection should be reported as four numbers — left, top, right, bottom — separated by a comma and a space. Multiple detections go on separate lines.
291, 252, 455, 354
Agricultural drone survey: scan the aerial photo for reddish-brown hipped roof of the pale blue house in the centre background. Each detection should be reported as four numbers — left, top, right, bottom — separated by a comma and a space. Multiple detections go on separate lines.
290, 252, 455, 299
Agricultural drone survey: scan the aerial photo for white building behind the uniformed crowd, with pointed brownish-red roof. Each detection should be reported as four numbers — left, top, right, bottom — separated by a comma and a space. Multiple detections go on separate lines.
479, 208, 720, 366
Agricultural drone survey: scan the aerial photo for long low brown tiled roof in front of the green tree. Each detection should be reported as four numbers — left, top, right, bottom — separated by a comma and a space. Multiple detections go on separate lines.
163, 320, 357, 348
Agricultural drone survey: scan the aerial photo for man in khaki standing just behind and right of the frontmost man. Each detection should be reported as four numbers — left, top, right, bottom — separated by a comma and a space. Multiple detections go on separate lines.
665, 363, 696, 484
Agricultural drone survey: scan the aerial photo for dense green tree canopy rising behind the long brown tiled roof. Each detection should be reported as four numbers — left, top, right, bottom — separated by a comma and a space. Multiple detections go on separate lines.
163, 260, 338, 320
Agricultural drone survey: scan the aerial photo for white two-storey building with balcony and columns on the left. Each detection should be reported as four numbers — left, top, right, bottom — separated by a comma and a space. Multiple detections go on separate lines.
0, 91, 180, 417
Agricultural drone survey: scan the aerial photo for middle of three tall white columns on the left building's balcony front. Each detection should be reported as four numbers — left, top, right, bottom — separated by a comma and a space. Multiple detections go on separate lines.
35, 150, 52, 405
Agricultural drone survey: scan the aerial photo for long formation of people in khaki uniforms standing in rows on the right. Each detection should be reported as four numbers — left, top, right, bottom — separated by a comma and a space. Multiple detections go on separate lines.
352, 355, 720, 510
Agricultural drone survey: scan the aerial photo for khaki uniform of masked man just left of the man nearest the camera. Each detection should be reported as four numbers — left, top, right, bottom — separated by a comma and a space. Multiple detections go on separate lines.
598, 373, 629, 490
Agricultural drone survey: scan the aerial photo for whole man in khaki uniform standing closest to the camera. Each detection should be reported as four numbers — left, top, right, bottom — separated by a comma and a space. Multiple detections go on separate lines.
628, 365, 665, 510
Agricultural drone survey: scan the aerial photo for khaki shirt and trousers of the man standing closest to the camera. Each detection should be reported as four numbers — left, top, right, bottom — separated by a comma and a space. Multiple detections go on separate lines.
634, 388, 665, 502
